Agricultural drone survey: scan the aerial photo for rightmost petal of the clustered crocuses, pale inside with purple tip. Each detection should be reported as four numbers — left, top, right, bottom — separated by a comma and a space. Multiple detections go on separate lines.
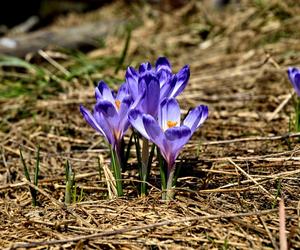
183, 105, 208, 133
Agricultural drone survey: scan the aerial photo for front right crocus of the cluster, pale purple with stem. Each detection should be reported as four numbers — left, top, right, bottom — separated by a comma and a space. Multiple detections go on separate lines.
129, 98, 208, 199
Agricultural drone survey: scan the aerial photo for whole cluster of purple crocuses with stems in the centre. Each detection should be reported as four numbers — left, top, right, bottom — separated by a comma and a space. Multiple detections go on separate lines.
80, 57, 208, 199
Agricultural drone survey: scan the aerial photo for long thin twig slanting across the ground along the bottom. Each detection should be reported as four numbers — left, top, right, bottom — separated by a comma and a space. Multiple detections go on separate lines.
8, 207, 295, 249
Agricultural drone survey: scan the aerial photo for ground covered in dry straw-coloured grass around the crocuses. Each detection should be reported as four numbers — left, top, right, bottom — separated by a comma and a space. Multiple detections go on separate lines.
0, 0, 300, 249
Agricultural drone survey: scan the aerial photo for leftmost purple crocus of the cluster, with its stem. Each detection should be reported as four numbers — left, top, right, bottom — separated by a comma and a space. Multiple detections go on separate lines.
80, 81, 133, 195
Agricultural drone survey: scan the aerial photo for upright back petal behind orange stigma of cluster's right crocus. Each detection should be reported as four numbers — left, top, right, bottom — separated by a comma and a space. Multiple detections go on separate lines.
158, 98, 180, 131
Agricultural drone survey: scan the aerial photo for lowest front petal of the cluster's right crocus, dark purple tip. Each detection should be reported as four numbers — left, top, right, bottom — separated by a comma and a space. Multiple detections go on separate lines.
165, 126, 192, 166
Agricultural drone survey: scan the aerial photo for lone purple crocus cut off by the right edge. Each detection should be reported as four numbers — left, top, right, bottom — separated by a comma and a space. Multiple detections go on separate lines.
287, 67, 300, 132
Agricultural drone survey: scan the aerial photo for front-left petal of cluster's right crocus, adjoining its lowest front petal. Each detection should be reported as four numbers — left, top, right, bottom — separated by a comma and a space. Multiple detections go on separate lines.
142, 114, 165, 150
